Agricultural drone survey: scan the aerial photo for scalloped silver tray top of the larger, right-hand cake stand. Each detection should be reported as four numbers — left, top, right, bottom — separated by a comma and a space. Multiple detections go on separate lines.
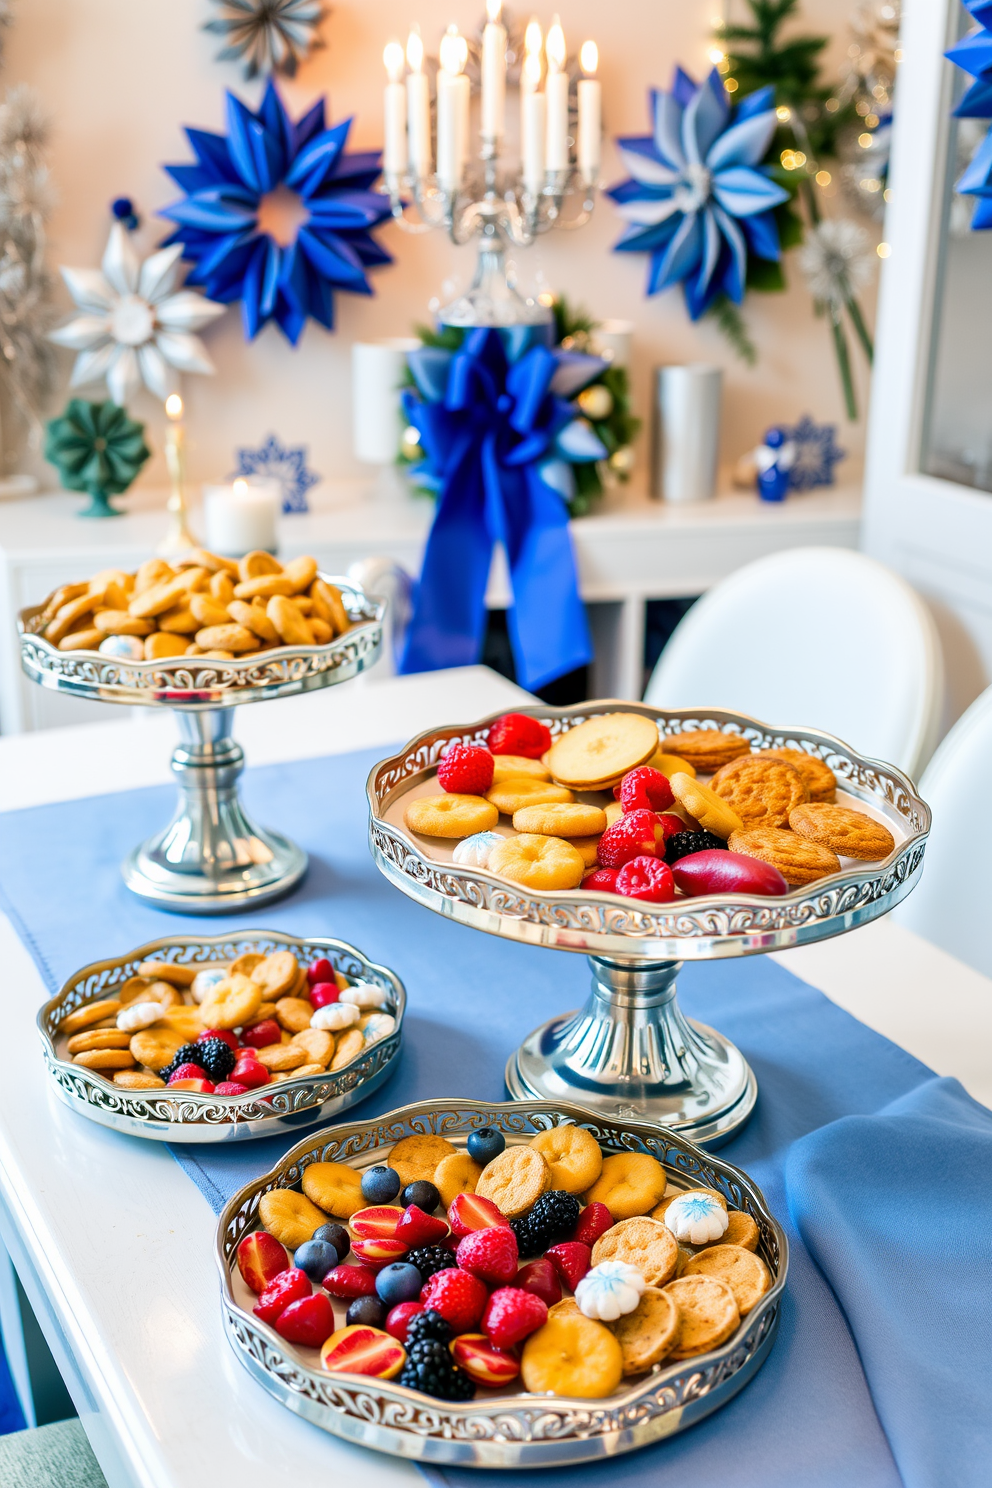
367, 699, 930, 963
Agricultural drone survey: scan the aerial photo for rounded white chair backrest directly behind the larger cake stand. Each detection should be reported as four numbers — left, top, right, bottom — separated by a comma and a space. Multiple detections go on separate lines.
644, 548, 943, 778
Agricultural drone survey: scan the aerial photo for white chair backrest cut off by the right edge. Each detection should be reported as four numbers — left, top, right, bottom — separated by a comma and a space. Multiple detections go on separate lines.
892, 687, 992, 976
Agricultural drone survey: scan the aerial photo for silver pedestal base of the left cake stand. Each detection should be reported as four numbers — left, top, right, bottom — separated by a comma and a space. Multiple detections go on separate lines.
120, 708, 306, 915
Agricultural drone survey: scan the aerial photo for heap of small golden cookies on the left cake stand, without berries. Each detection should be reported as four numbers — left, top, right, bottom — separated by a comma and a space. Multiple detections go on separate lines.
32, 548, 352, 661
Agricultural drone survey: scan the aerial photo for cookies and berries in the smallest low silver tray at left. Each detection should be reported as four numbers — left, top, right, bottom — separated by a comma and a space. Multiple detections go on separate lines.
54, 951, 396, 1097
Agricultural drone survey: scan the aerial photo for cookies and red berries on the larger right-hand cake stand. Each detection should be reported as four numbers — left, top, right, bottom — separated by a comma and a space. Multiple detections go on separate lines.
403, 713, 895, 903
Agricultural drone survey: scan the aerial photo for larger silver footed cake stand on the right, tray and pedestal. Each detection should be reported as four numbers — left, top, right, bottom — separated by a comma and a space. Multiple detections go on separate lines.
367, 701, 930, 1147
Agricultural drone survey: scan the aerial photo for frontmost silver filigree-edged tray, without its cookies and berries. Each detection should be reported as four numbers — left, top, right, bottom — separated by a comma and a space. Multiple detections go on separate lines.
216, 1100, 788, 1469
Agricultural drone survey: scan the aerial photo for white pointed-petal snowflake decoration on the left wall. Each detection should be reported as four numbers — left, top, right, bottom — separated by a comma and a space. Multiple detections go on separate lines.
49, 222, 225, 406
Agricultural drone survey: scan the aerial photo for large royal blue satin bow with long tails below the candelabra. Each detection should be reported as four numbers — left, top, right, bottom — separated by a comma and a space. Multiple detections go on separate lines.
400, 327, 607, 692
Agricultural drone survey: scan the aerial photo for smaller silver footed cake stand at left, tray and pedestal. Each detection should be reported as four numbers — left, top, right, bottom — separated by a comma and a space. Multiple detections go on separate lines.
18, 574, 385, 915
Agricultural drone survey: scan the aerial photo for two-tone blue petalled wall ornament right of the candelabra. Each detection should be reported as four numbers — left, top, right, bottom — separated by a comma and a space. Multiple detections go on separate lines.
610, 67, 788, 320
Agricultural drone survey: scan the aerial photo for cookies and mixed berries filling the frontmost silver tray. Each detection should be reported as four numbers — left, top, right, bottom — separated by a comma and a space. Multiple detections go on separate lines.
230, 1123, 772, 1400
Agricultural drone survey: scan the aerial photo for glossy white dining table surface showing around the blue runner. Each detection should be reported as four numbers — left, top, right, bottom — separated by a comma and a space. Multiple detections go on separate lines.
0, 667, 992, 1488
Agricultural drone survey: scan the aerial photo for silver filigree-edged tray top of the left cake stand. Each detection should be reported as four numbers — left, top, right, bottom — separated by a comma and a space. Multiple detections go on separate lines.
18, 573, 385, 710
